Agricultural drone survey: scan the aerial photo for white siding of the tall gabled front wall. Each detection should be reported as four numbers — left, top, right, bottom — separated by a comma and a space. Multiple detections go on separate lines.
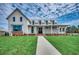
8, 10, 29, 34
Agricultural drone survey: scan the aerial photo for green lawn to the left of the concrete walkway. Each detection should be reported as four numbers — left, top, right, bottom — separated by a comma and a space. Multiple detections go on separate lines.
0, 36, 37, 55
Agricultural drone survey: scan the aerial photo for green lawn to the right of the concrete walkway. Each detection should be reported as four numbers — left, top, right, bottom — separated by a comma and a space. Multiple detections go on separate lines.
46, 36, 79, 55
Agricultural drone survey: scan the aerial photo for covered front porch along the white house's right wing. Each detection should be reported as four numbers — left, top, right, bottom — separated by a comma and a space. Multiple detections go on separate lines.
29, 25, 66, 34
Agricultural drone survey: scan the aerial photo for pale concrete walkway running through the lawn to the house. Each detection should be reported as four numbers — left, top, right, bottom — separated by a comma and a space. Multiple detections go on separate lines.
36, 36, 61, 55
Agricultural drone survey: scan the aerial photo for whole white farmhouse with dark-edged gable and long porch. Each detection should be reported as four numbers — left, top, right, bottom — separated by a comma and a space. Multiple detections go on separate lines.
7, 8, 68, 35
